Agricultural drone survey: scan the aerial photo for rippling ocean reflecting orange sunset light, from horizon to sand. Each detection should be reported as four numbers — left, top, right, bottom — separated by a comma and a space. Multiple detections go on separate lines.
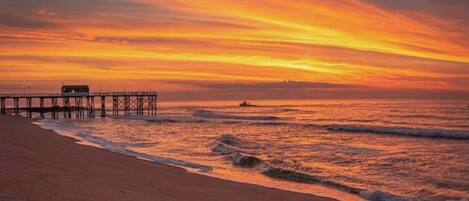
38, 100, 469, 201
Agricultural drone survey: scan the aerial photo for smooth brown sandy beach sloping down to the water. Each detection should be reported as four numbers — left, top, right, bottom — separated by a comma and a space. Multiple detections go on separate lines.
0, 116, 333, 201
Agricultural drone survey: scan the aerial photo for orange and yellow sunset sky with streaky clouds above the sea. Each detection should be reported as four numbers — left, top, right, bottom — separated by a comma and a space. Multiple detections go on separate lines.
0, 0, 469, 98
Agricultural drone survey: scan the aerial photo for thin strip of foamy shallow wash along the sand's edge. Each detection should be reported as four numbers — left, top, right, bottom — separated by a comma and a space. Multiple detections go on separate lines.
32, 119, 366, 201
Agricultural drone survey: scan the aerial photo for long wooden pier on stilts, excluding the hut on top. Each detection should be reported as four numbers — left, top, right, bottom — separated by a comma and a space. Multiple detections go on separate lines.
0, 92, 158, 118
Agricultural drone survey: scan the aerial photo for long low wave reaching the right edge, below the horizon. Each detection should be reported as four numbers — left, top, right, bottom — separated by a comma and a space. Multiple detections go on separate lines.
326, 125, 469, 140
